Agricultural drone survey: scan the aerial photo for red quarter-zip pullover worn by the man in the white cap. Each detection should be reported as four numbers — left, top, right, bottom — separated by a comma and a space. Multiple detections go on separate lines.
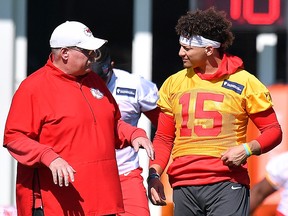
4, 59, 145, 216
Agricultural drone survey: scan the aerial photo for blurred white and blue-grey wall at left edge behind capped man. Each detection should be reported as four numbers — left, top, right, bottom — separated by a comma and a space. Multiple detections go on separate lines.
0, 0, 27, 206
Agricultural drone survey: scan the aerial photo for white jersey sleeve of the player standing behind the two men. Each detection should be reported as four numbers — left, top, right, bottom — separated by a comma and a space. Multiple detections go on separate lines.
138, 77, 159, 112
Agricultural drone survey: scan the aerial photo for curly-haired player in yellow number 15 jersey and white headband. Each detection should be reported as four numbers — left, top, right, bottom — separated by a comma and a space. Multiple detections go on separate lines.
147, 8, 282, 216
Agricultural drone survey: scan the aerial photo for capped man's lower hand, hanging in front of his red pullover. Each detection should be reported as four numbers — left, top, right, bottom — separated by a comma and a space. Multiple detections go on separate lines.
49, 157, 76, 187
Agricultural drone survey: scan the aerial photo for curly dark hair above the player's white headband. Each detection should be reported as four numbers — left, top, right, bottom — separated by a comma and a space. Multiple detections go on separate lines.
175, 7, 234, 52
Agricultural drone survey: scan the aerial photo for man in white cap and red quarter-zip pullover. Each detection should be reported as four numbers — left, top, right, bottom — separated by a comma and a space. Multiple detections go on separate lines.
4, 21, 154, 216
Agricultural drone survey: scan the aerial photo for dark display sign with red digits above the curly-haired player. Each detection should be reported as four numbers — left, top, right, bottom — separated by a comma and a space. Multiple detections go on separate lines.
197, 0, 286, 29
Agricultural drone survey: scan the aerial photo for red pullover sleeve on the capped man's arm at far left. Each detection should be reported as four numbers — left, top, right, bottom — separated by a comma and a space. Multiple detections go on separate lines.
4, 85, 59, 166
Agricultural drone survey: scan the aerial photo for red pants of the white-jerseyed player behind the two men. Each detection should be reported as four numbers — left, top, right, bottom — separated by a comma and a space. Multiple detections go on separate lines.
118, 167, 150, 216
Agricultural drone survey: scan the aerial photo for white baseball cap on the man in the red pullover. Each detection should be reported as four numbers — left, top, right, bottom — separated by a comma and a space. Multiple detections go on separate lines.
50, 21, 108, 50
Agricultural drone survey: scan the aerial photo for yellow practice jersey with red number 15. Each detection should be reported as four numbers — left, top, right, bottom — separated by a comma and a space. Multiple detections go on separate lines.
158, 69, 272, 158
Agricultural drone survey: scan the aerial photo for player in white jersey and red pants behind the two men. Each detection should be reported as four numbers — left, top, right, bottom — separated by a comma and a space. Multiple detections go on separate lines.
92, 44, 159, 216
